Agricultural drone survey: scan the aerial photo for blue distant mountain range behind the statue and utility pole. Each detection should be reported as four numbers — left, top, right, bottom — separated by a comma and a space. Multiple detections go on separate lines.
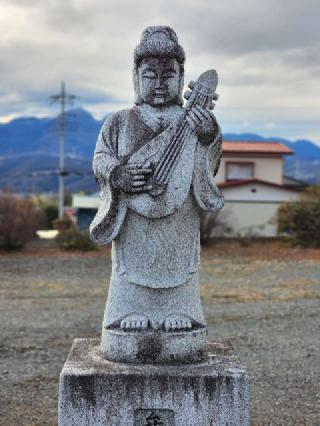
0, 108, 320, 192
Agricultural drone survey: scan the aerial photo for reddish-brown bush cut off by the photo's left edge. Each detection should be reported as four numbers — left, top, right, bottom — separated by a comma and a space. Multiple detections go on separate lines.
0, 192, 44, 250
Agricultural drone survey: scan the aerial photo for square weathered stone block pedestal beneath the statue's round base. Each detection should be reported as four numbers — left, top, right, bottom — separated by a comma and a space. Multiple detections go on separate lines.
59, 339, 249, 426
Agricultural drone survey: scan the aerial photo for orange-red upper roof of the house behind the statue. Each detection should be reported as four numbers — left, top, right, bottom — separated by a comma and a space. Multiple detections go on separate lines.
222, 141, 293, 155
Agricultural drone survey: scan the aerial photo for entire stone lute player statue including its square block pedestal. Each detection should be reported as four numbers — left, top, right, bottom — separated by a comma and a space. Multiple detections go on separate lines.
59, 27, 249, 426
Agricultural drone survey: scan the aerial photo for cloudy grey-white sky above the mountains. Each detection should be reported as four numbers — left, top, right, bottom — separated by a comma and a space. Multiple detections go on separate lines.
0, 0, 320, 145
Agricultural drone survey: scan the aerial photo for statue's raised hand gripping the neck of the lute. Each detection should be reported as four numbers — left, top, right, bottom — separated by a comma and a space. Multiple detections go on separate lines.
186, 105, 218, 144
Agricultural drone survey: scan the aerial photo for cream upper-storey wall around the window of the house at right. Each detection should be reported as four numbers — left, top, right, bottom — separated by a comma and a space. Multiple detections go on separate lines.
215, 154, 283, 185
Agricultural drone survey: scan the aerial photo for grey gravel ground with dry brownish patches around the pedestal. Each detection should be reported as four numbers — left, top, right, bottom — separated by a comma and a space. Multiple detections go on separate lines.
0, 243, 320, 426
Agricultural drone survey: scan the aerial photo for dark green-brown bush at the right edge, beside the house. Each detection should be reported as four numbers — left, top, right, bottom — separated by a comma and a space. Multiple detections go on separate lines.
277, 186, 320, 247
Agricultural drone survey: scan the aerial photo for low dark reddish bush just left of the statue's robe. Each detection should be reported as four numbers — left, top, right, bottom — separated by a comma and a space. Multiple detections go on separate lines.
56, 226, 98, 251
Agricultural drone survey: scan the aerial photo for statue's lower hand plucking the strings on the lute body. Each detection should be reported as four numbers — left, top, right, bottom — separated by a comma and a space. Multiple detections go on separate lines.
111, 164, 152, 194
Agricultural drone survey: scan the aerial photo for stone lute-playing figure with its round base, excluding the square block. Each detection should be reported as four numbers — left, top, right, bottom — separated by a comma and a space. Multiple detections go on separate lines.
90, 26, 223, 360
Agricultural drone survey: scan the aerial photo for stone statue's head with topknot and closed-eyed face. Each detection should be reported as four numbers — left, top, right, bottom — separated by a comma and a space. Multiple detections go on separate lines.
133, 27, 185, 107
